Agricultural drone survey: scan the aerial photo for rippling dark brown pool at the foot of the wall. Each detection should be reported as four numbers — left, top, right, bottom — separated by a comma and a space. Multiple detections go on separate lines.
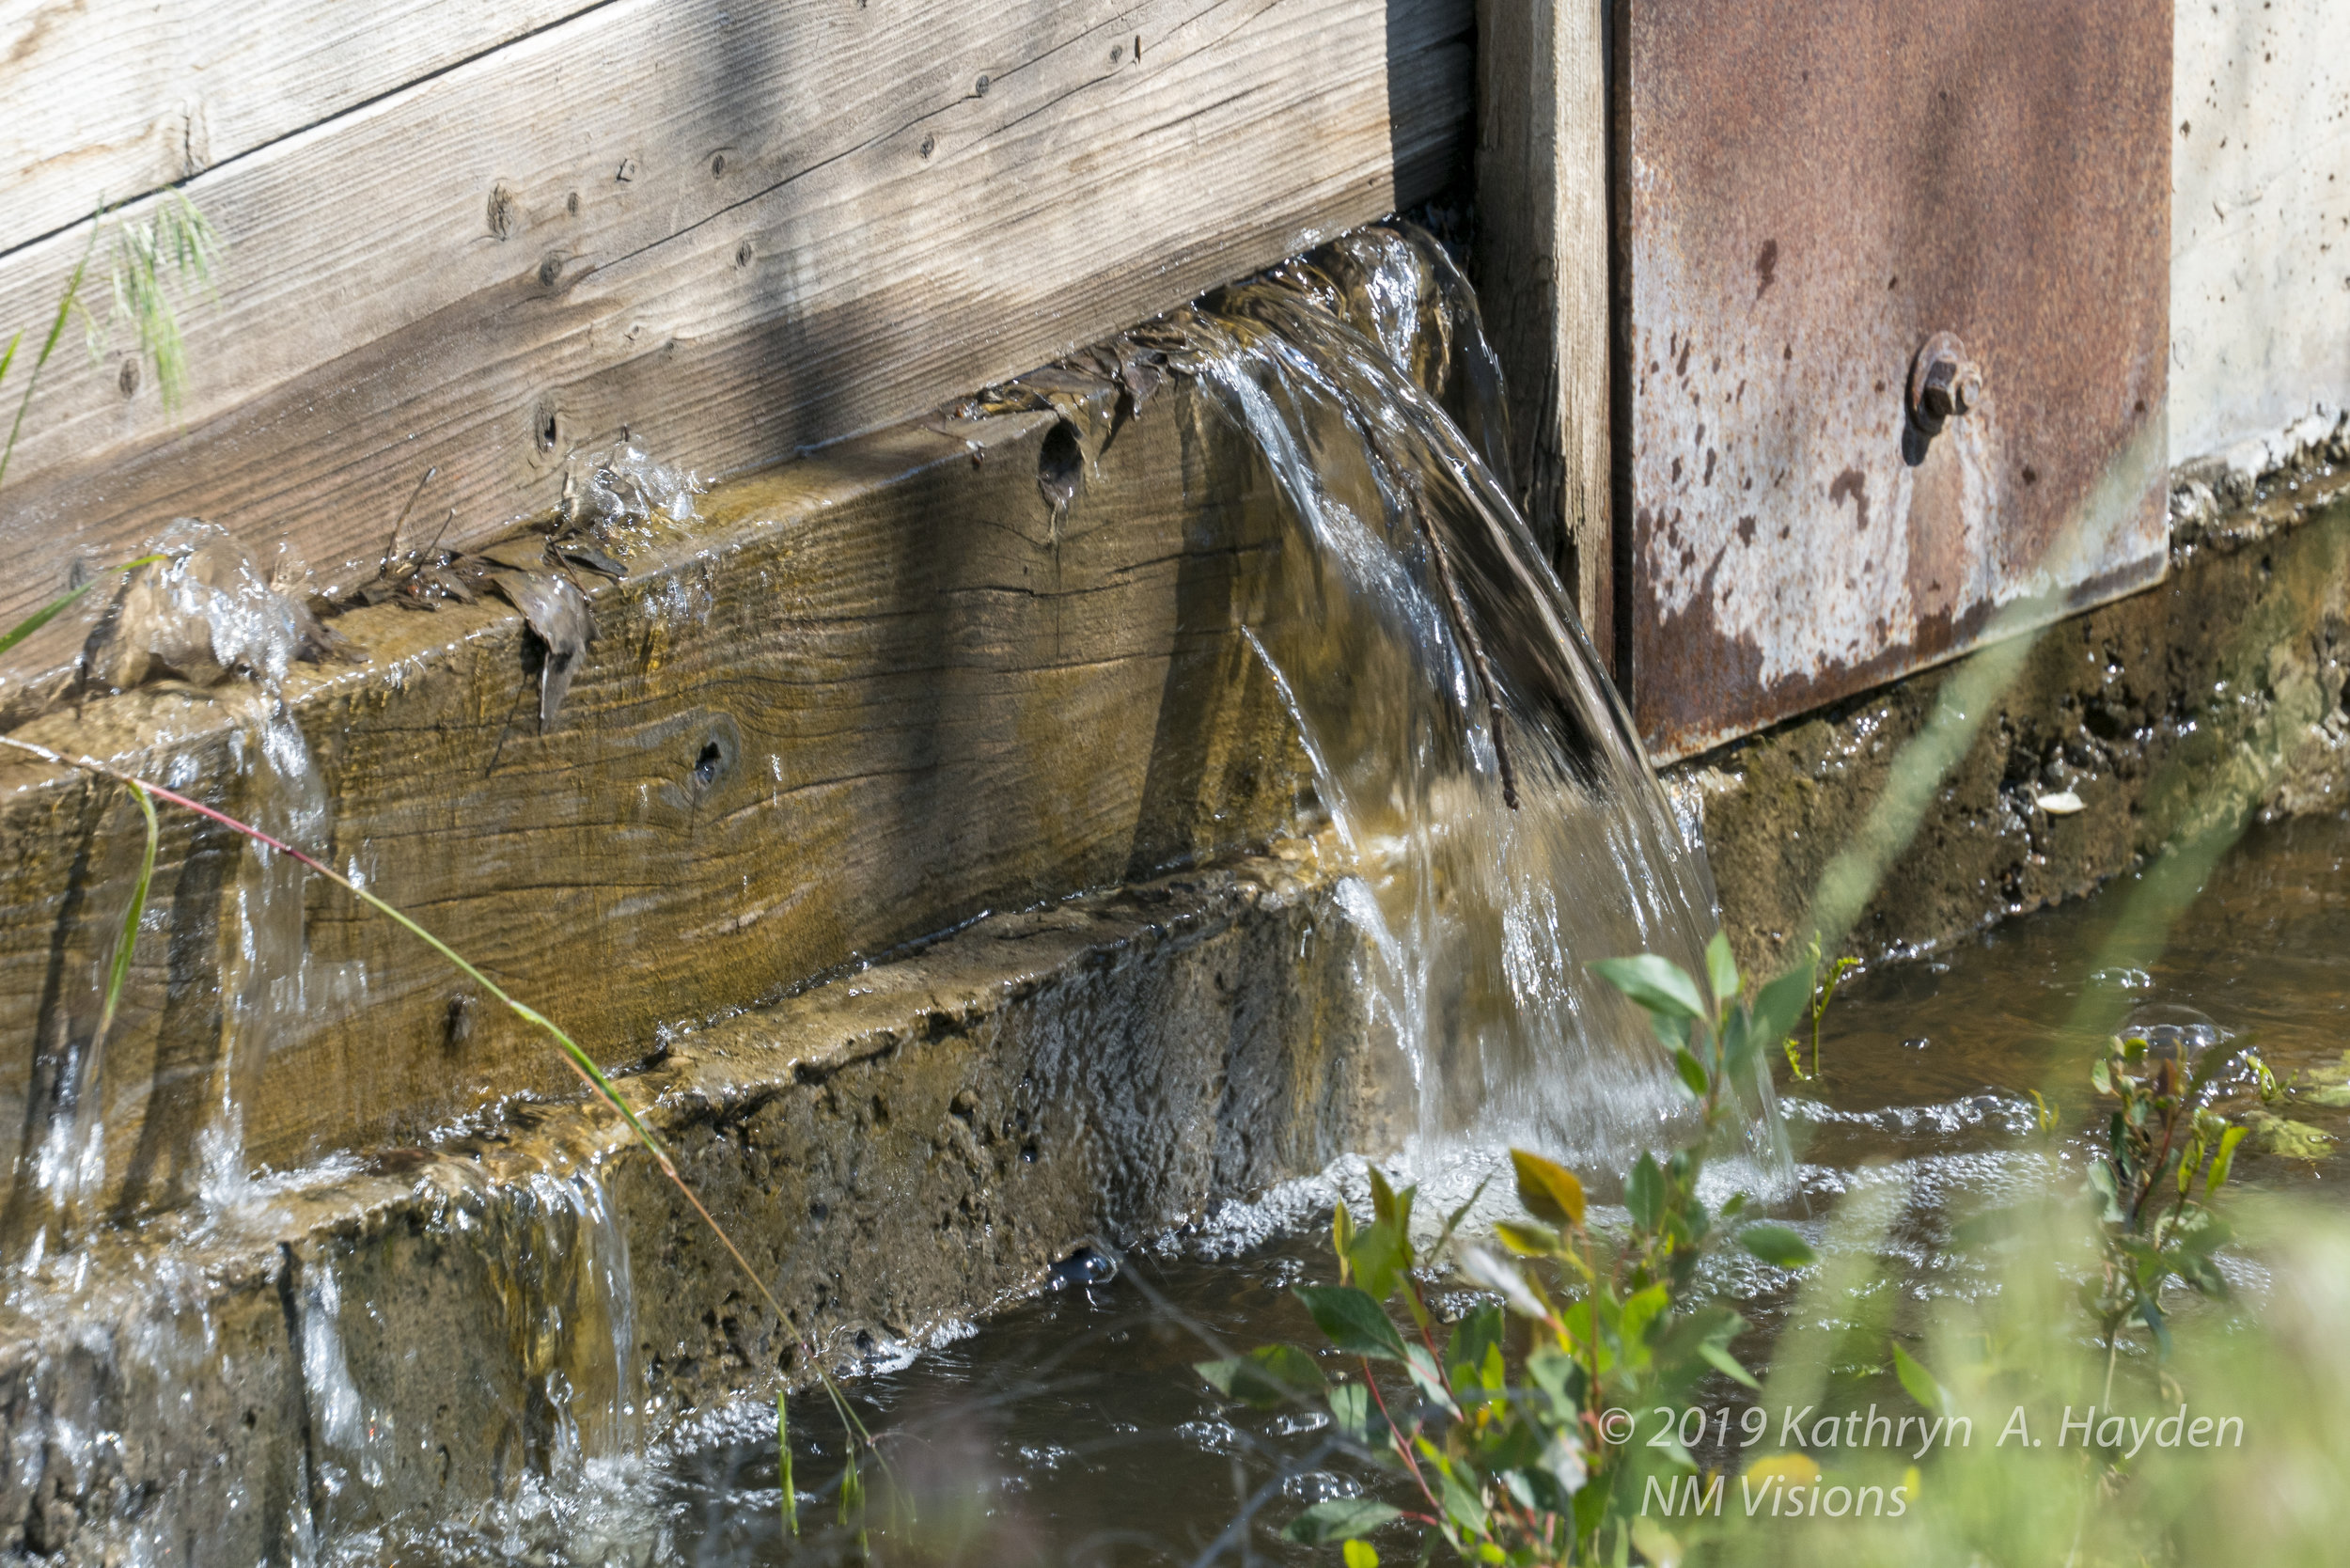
362, 818, 2350, 1565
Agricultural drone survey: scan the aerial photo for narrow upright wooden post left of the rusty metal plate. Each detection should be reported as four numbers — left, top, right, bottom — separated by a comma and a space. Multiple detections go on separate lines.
1476, 0, 1615, 658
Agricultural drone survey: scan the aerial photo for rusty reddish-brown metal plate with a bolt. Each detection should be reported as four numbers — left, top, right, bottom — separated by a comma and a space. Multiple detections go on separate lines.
1617, 0, 2171, 760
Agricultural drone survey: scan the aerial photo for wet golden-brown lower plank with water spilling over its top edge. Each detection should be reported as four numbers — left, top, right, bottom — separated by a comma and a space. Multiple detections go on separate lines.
0, 376, 1309, 1225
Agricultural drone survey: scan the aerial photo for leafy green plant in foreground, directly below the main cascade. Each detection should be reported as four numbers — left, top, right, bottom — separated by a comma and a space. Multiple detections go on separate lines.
1198, 935, 1812, 1568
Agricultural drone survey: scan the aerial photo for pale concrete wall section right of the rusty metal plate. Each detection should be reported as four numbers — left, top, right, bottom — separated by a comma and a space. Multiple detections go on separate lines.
2170, 0, 2350, 473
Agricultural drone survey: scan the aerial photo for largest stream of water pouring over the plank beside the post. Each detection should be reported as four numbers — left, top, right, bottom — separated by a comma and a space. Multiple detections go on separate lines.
1161, 226, 1786, 1168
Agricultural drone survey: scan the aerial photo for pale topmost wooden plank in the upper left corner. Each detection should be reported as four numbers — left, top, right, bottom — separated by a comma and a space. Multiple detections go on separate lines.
0, 0, 595, 254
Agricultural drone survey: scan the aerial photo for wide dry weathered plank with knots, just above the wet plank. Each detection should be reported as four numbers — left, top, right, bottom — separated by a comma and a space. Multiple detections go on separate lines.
0, 0, 1471, 616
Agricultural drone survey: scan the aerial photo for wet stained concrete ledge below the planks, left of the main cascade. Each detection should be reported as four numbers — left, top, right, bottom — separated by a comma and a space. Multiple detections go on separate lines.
0, 839, 1410, 1563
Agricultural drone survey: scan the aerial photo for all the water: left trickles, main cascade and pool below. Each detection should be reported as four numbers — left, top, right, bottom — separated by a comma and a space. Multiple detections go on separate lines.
9, 228, 2350, 1565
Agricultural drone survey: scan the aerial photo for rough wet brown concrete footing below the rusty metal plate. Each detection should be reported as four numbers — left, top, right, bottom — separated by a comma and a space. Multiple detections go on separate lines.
1668, 472, 2350, 966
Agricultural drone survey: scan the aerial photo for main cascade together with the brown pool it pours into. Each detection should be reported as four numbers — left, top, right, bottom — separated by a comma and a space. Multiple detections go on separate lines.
326, 235, 2350, 1565
